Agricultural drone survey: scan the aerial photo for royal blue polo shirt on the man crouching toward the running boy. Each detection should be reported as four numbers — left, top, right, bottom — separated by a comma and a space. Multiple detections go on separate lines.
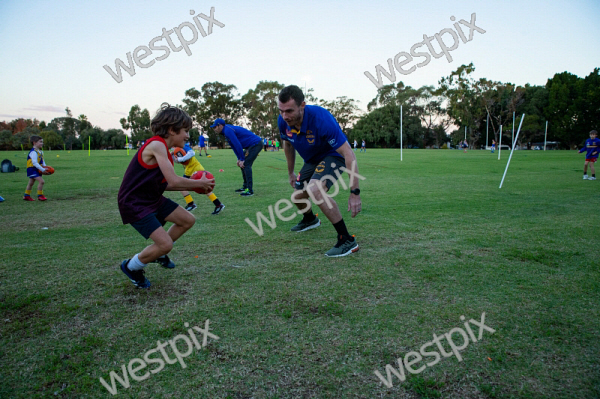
277, 105, 348, 164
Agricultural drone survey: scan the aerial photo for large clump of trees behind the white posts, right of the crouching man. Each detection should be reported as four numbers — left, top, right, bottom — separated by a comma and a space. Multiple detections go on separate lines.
349, 63, 600, 148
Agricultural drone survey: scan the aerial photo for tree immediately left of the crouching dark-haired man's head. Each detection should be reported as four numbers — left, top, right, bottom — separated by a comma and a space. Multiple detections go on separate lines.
242, 81, 285, 137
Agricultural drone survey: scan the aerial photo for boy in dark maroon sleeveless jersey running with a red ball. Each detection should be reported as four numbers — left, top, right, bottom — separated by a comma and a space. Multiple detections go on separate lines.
118, 104, 215, 288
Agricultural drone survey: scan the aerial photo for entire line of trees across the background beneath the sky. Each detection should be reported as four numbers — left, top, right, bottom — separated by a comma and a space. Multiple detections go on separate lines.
0, 63, 600, 149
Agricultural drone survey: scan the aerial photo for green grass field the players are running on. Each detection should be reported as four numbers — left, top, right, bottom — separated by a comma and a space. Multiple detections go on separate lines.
0, 150, 600, 399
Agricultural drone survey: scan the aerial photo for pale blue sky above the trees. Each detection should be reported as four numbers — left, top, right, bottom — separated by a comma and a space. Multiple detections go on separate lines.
0, 0, 600, 129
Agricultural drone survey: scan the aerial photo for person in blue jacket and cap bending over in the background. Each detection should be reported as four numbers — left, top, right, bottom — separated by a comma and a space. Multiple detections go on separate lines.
210, 118, 263, 197
